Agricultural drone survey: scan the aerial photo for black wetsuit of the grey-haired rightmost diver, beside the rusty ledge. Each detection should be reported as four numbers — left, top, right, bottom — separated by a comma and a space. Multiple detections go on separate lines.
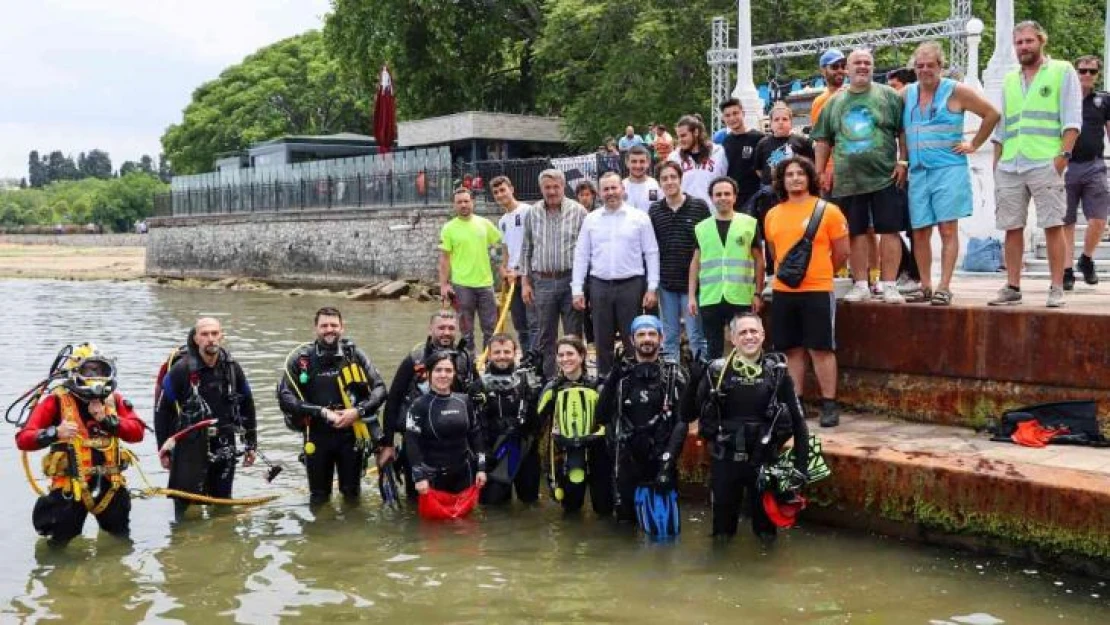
686, 354, 809, 536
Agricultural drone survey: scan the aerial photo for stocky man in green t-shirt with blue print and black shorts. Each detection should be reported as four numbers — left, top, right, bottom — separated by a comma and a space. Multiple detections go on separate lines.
811, 50, 909, 304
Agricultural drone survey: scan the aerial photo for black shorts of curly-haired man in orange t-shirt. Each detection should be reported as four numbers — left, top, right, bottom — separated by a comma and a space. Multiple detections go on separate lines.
770, 291, 836, 352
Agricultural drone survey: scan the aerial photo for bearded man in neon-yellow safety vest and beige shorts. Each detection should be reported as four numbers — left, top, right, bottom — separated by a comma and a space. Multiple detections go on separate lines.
989, 21, 1083, 309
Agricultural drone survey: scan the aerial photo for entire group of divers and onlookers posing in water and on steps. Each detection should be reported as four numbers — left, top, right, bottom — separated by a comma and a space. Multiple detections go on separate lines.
17, 22, 1110, 543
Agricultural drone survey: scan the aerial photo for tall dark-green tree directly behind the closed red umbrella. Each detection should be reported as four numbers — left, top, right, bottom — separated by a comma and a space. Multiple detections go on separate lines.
324, 0, 545, 119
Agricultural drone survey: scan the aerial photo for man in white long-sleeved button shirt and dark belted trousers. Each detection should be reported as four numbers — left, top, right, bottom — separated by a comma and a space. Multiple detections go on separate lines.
571, 172, 659, 375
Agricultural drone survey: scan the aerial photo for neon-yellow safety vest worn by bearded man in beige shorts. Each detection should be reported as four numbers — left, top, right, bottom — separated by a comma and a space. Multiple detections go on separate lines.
1001, 60, 1070, 162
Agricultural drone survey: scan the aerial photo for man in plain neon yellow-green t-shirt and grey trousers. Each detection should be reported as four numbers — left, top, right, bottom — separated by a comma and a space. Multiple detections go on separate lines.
440, 188, 501, 346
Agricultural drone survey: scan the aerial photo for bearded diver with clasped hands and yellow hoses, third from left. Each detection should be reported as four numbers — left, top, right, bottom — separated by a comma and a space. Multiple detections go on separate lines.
278, 306, 385, 505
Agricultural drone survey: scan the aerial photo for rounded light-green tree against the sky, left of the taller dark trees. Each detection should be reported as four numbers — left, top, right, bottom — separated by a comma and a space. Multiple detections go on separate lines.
160, 31, 371, 173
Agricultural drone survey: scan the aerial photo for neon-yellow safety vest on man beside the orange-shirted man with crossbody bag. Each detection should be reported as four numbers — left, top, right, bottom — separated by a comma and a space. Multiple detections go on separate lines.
694, 213, 758, 306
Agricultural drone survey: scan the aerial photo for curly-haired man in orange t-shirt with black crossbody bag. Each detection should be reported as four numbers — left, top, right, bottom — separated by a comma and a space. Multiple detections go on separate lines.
764, 157, 849, 427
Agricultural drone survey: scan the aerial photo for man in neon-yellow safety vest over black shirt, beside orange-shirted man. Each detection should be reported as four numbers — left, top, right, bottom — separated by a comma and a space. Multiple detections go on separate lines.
688, 177, 764, 360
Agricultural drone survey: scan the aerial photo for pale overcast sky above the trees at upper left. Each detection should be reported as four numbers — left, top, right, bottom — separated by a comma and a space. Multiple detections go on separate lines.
0, 0, 329, 178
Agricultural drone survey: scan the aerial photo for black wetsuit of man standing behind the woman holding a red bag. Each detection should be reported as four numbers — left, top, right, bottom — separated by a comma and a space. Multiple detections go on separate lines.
382, 337, 477, 498
